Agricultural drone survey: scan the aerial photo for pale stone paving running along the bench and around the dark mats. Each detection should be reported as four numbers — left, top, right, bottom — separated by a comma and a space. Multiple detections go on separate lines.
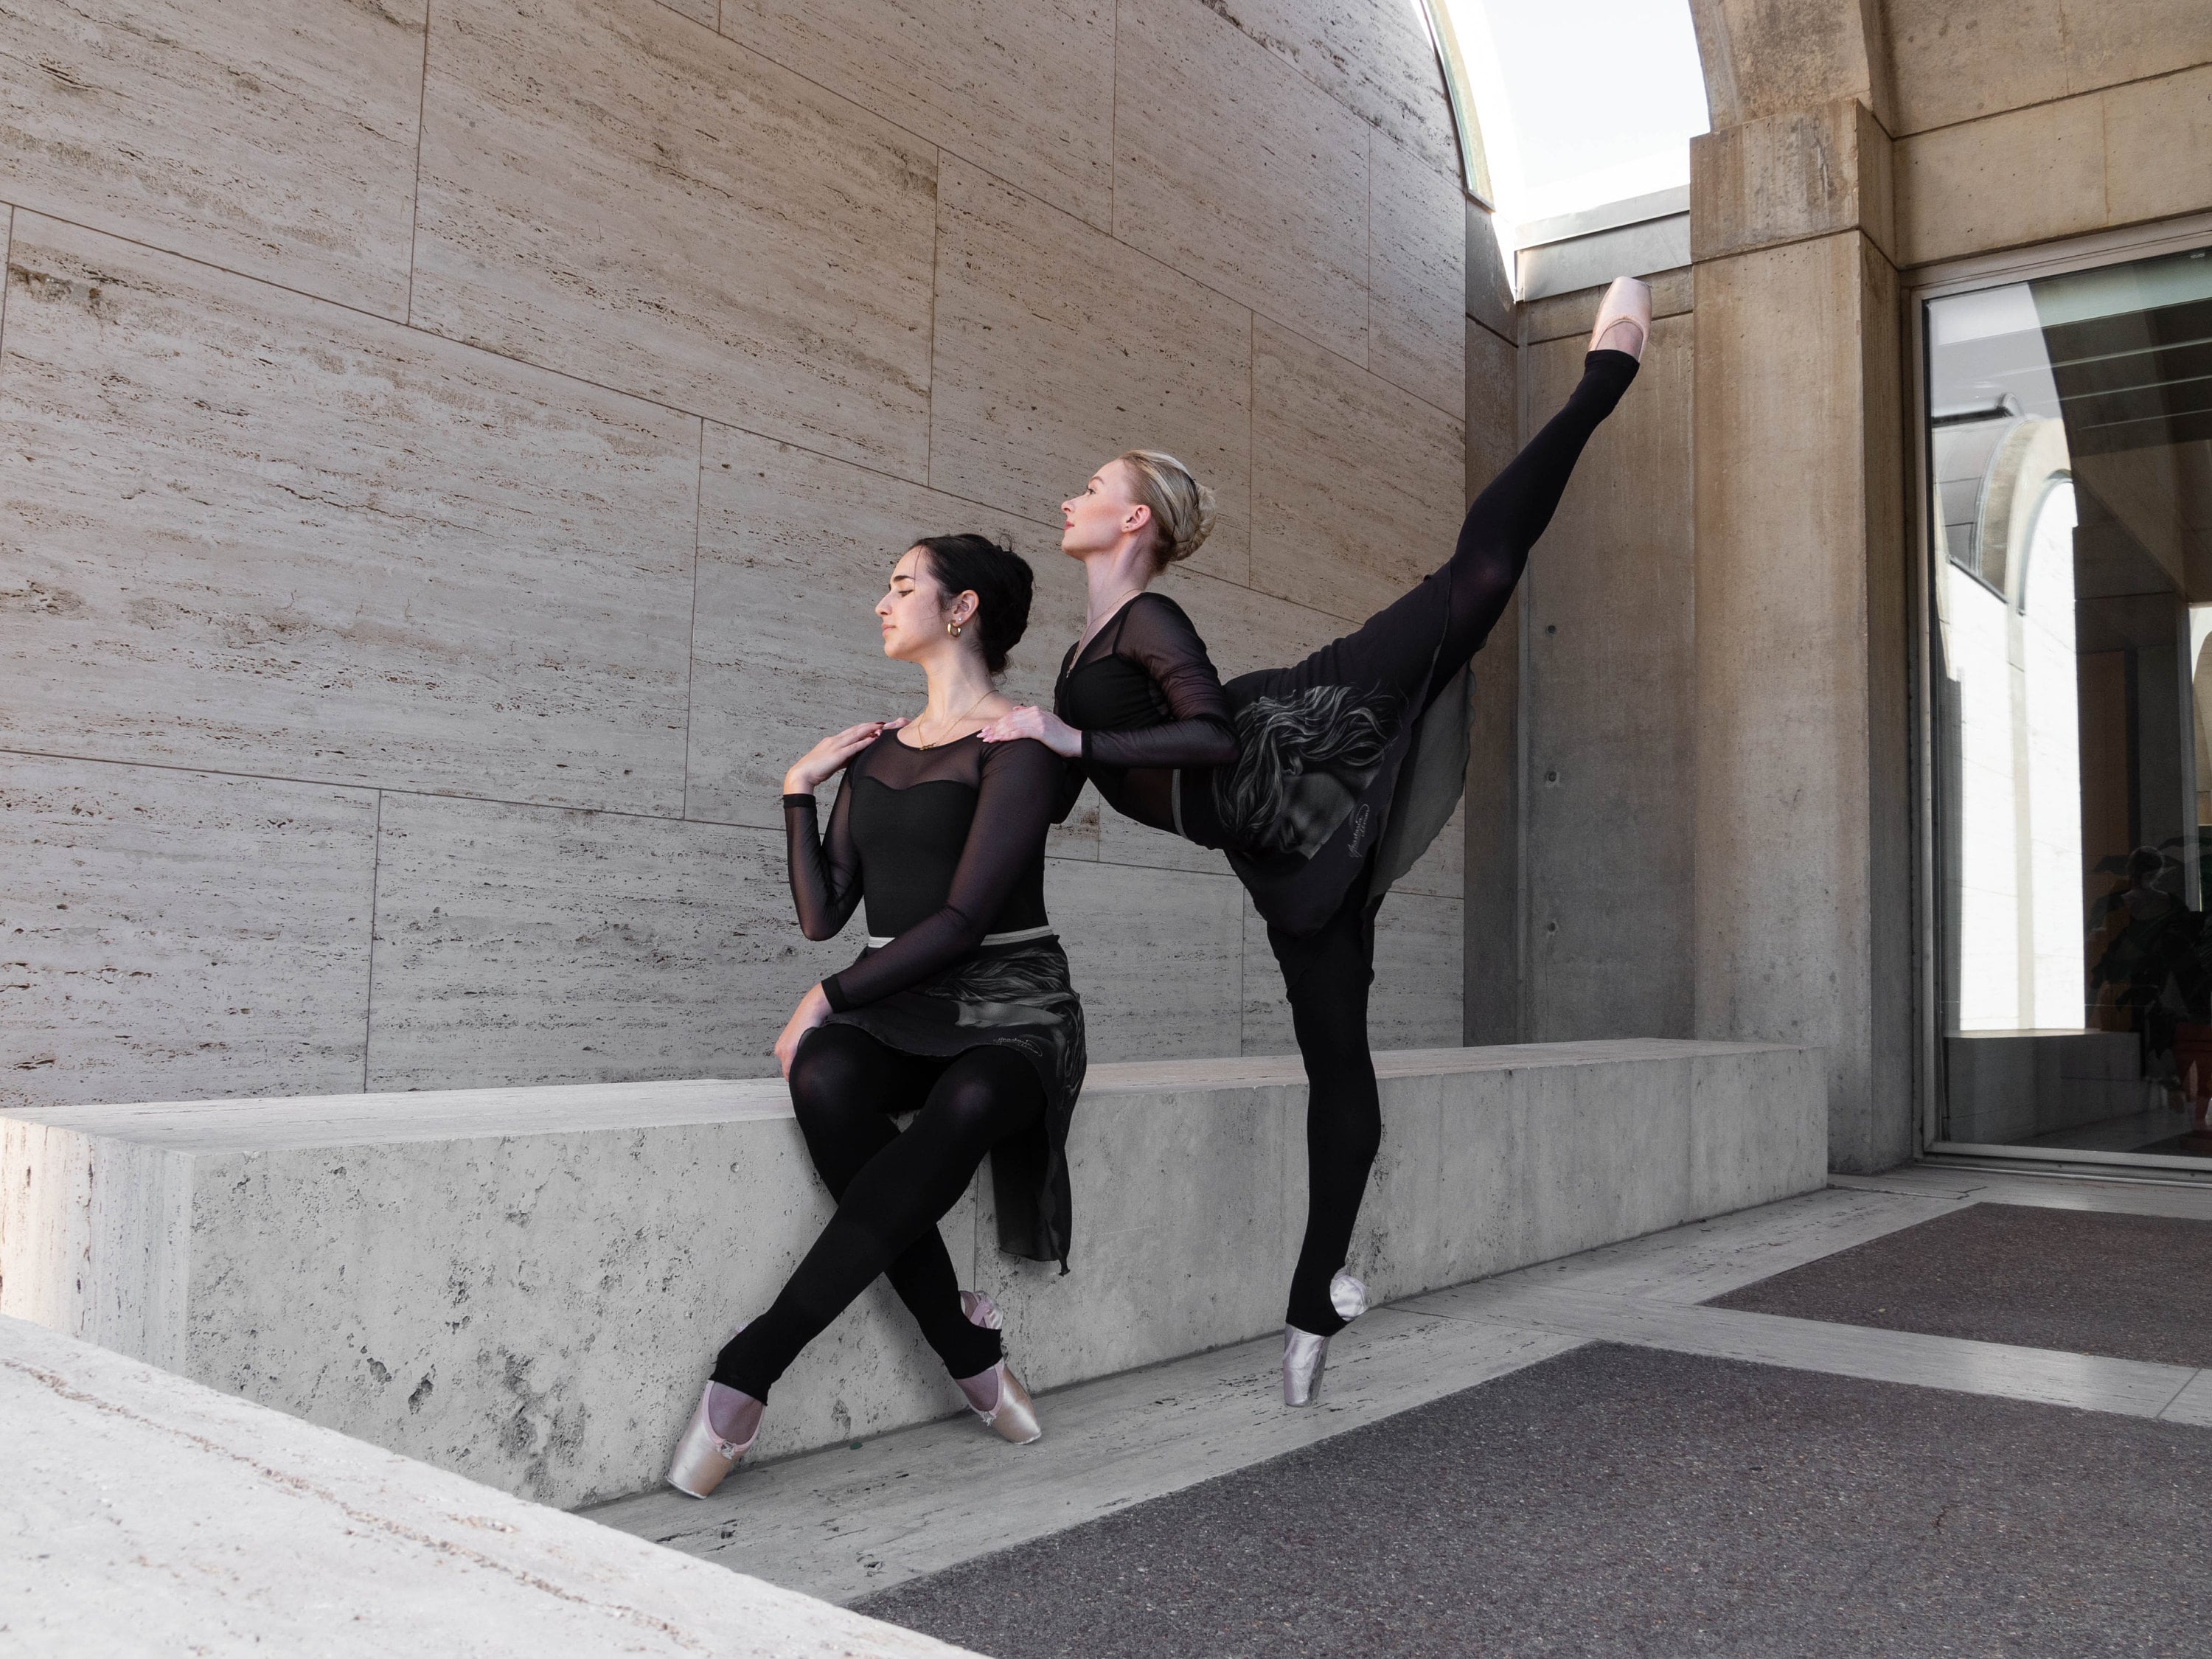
593, 1166, 2212, 1652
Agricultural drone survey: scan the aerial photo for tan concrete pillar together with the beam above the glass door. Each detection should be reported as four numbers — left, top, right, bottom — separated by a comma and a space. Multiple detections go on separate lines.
1690, 0, 2212, 1170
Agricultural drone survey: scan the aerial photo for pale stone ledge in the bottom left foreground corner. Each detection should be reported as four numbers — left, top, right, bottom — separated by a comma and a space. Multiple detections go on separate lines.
0, 1318, 962, 1659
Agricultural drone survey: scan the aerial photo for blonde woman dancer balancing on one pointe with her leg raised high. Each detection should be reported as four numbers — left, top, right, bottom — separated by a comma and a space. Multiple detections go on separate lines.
982, 276, 1650, 1405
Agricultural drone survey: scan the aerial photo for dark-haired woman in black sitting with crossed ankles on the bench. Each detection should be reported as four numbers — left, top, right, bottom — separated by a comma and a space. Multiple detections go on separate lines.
668, 535, 1084, 1498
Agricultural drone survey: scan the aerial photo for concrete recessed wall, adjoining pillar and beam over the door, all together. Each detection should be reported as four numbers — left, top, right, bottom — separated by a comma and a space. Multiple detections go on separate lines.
1467, 0, 2212, 1170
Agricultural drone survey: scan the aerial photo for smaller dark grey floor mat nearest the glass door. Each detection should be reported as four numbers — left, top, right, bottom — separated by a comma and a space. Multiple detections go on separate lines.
1708, 1203, 2212, 1365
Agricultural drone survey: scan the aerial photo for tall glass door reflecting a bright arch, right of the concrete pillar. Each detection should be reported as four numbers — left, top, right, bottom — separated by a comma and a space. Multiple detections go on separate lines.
1924, 240, 2212, 1168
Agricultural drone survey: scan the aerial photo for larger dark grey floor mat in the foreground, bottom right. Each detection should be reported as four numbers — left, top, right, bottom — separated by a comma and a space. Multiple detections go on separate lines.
863, 1345, 2212, 1659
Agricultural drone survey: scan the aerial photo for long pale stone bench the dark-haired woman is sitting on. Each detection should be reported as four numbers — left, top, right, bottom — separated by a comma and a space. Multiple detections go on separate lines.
0, 1040, 1827, 1506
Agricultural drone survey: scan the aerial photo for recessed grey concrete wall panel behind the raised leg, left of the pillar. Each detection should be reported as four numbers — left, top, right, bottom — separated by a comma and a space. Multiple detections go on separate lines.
1467, 232, 1697, 1042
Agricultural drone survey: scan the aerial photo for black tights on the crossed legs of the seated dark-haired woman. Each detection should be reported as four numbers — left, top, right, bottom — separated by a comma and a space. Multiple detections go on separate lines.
714, 1024, 1044, 1400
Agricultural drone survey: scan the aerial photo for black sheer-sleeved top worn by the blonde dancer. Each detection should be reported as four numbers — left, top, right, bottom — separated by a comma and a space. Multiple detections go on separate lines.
1053, 593, 1237, 830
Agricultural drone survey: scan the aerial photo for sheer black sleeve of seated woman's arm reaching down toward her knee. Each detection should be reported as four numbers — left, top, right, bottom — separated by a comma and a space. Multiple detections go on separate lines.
823, 743, 1062, 1009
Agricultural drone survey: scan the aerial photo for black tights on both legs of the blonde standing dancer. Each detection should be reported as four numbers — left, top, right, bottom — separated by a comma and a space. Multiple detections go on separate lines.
1267, 352, 1637, 1336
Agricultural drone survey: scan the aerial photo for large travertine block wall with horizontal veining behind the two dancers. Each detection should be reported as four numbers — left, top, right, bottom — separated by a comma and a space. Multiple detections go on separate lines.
0, 0, 1500, 1106
